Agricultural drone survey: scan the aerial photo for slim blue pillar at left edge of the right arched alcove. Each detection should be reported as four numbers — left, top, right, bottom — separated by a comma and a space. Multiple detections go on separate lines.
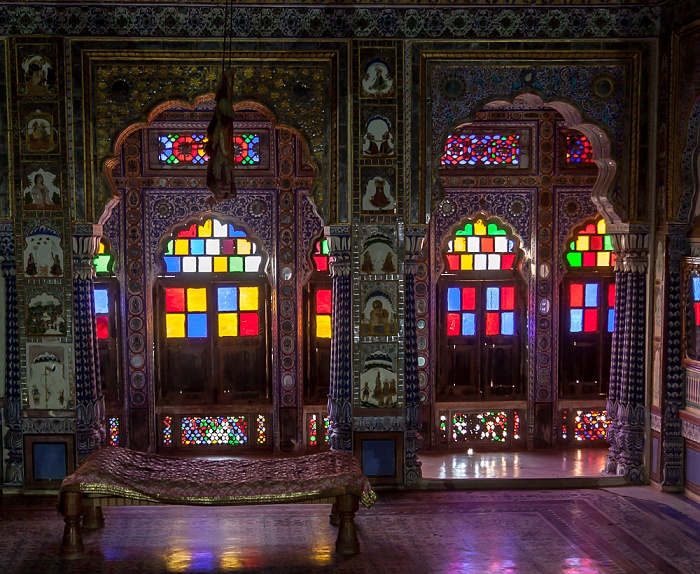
404, 226, 425, 485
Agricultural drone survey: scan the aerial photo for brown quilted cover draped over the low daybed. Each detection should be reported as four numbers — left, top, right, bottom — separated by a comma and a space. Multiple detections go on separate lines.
61, 446, 376, 508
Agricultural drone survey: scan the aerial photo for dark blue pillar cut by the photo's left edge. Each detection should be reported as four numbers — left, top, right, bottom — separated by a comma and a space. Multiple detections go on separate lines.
0, 230, 24, 486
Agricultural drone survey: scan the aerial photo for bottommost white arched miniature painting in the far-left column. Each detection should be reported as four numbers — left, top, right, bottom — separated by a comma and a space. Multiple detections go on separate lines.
27, 343, 75, 410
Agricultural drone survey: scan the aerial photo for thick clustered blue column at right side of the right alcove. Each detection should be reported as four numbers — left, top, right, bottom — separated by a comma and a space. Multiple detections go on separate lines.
605, 229, 649, 482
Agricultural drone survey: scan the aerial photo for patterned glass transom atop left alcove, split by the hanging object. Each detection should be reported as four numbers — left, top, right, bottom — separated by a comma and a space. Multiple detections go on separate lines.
158, 132, 260, 166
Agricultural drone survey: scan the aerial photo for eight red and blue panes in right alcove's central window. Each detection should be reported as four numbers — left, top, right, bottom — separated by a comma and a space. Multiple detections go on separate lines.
446, 285, 515, 337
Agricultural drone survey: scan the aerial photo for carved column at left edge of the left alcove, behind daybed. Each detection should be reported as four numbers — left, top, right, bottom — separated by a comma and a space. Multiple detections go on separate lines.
73, 225, 105, 463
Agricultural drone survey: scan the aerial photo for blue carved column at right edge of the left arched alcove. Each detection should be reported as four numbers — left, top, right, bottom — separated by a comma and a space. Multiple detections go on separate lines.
325, 225, 352, 452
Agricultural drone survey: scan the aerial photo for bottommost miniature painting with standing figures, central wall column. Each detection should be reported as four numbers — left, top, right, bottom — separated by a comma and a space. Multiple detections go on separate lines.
360, 344, 400, 409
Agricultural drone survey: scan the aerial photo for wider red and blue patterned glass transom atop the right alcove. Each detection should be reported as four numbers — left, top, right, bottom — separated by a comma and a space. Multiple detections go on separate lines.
440, 134, 520, 166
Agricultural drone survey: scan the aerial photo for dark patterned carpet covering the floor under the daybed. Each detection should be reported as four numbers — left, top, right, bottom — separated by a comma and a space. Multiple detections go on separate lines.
0, 488, 700, 574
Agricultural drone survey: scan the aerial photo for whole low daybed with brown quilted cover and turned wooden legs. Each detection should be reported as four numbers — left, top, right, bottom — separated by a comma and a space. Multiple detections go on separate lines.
59, 446, 376, 558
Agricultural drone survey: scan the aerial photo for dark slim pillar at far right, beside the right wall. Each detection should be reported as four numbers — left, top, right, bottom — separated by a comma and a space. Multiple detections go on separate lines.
661, 232, 688, 491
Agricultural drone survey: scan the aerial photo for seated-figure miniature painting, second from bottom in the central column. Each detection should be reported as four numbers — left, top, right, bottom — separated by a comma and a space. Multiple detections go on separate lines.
360, 281, 399, 337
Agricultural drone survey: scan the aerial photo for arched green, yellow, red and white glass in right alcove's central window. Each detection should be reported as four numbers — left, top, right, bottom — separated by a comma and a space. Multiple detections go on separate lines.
446, 219, 515, 271
